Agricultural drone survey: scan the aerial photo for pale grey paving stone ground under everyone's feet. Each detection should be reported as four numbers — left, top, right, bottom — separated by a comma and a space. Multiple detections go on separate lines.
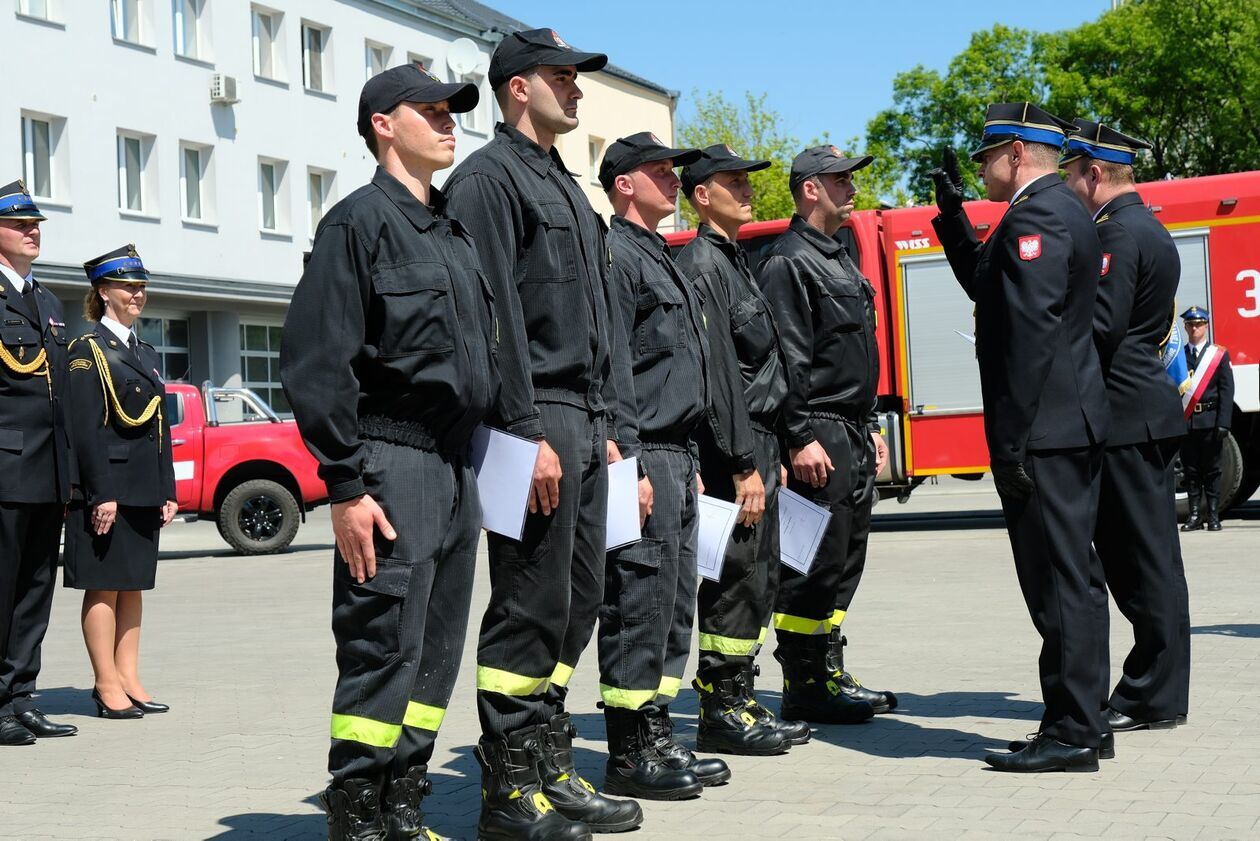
0, 482, 1260, 841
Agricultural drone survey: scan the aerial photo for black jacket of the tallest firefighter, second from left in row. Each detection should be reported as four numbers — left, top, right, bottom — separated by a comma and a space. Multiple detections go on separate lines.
445, 124, 629, 446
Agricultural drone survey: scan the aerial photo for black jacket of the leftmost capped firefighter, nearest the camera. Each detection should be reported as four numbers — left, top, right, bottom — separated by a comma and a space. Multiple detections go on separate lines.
280, 168, 499, 502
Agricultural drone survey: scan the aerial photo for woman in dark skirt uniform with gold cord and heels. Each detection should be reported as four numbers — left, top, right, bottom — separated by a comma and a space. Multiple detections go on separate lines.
66, 246, 178, 719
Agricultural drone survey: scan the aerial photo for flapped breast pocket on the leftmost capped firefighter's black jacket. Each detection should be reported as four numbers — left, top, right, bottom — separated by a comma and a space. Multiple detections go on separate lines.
372, 262, 455, 358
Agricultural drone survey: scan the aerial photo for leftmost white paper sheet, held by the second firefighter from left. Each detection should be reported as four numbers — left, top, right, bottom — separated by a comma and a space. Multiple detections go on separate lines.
473, 426, 539, 540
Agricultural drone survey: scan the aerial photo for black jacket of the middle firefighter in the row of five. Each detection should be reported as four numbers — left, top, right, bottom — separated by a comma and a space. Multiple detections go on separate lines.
609, 216, 715, 456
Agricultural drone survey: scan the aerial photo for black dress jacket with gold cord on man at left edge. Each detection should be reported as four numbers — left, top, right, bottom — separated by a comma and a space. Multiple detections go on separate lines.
0, 274, 77, 504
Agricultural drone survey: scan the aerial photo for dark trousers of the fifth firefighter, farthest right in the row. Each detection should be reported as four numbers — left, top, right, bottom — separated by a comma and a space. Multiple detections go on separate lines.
774, 414, 874, 648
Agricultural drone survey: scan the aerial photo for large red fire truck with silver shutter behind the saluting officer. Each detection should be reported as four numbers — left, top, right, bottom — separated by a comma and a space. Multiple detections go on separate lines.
667, 171, 1260, 507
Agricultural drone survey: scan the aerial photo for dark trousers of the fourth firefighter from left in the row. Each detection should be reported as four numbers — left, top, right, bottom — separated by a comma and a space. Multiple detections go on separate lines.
696, 425, 780, 676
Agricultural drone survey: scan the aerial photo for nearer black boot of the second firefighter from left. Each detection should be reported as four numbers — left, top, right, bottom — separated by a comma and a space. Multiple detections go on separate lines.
474, 725, 591, 841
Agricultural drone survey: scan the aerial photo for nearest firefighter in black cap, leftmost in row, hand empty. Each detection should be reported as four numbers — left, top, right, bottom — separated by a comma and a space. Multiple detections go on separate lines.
280, 64, 496, 840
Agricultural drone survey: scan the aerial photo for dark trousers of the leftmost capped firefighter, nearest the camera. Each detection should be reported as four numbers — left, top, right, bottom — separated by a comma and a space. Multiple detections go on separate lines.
329, 440, 481, 784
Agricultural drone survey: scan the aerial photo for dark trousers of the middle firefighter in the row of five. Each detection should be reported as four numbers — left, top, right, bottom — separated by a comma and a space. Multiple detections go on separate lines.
599, 444, 698, 710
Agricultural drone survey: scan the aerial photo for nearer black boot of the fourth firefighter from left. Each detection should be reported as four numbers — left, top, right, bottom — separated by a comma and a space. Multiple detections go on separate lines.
692, 667, 791, 757
